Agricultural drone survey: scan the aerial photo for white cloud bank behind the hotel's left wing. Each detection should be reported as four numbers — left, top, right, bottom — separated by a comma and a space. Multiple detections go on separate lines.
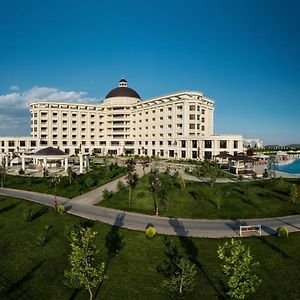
0, 86, 99, 135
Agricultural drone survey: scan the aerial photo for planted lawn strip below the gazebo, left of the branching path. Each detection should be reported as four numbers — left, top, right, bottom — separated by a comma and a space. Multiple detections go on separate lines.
4, 164, 125, 198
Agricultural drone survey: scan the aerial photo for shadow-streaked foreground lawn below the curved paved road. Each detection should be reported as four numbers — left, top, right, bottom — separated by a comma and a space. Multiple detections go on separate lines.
0, 196, 300, 300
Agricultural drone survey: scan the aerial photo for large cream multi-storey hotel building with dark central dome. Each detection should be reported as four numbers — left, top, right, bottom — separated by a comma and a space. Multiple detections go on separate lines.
0, 79, 244, 159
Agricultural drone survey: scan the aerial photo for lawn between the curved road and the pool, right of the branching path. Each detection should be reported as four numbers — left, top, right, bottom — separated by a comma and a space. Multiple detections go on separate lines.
99, 174, 300, 219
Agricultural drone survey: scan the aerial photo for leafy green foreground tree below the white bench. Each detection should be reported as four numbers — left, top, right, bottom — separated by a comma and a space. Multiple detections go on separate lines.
218, 239, 261, 299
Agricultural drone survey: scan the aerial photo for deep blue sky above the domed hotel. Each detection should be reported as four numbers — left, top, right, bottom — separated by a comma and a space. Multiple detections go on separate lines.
0, 0, 300, 144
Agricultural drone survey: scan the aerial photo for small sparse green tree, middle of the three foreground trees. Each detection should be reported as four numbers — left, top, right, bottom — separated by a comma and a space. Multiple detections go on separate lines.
162, 258, 197, 295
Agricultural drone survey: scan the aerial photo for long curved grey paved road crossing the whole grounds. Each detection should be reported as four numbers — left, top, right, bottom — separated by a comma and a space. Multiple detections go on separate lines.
0, 188, 300, 238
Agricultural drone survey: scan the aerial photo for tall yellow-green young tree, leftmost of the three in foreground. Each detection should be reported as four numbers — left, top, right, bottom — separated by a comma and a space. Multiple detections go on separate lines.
65, 227, 105, 300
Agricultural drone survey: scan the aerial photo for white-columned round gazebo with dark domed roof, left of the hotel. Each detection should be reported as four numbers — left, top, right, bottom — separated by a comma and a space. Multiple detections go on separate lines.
21, 147, 69, 171
